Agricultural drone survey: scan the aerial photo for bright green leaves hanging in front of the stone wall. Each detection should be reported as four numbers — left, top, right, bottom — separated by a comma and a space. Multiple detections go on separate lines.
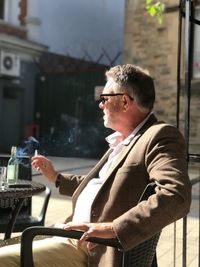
146, 0, 165, 24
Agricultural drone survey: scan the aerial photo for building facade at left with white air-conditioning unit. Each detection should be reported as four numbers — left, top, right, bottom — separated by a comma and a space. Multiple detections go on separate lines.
0, 0, 47, 153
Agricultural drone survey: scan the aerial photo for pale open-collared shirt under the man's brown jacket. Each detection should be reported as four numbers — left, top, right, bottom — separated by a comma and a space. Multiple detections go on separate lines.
72, 113, 152, 223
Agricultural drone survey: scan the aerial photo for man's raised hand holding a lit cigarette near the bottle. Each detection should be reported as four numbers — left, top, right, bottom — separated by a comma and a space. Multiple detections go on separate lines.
32, 155, 57, 182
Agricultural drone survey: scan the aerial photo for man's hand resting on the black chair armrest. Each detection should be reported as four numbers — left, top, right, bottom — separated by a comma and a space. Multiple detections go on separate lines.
64, 222, 116, 250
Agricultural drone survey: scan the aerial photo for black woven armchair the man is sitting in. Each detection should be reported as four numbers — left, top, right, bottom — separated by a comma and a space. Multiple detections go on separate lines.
20, 183, 160, 267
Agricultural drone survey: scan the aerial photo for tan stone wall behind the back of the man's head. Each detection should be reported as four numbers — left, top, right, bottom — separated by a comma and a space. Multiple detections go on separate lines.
123, 0, 200, 153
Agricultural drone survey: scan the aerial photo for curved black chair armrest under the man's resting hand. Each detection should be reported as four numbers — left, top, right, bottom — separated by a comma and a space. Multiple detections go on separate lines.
20, 226, 122, 267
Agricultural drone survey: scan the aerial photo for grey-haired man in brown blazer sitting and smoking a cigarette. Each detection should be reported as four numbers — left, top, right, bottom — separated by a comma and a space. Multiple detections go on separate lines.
0, 64, 191, 267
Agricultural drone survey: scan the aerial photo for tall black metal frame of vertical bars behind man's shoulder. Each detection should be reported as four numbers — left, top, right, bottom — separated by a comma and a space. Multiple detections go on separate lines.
177, 0, 200, 267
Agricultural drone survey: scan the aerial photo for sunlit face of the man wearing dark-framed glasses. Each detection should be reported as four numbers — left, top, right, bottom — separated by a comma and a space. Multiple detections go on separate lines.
99, 80, 122, 131
